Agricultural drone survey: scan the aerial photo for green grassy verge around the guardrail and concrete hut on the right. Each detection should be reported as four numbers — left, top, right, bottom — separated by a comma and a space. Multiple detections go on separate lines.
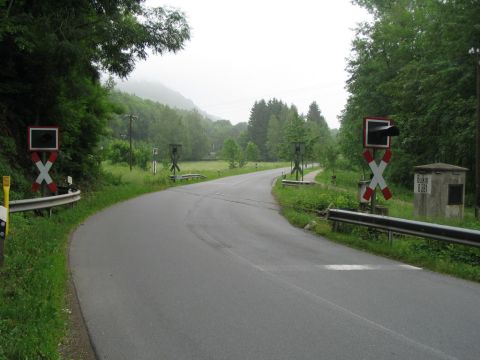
273, 171, 480, 282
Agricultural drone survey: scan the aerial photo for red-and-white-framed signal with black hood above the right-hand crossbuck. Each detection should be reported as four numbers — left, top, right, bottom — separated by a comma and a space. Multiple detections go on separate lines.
363, 117, 400, 149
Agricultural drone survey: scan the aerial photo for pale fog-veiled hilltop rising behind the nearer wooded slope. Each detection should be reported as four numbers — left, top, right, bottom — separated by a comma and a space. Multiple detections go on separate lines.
115, 80, 220, 120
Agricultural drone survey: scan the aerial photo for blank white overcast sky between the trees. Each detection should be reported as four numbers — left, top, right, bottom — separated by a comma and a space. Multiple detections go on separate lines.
130, 0, 370, 128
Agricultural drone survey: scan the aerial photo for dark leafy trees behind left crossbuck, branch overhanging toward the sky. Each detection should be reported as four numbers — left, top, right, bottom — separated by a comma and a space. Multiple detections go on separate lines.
0, 0, 190, 184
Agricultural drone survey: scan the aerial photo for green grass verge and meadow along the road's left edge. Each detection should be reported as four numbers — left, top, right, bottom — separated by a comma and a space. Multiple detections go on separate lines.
0, 162, 285, 360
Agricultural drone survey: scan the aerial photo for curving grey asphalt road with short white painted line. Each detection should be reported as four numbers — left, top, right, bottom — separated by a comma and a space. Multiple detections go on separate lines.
70, 170, 480, 360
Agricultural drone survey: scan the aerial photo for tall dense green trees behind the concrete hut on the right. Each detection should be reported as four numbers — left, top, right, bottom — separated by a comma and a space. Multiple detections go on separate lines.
339, 0, 480, 188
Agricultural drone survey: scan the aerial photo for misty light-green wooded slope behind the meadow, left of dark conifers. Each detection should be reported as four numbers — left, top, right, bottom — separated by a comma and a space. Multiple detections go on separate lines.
103, 91, 247, 160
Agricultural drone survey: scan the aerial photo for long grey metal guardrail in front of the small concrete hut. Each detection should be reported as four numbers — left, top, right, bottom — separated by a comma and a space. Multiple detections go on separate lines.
327, 209, 480, 247
